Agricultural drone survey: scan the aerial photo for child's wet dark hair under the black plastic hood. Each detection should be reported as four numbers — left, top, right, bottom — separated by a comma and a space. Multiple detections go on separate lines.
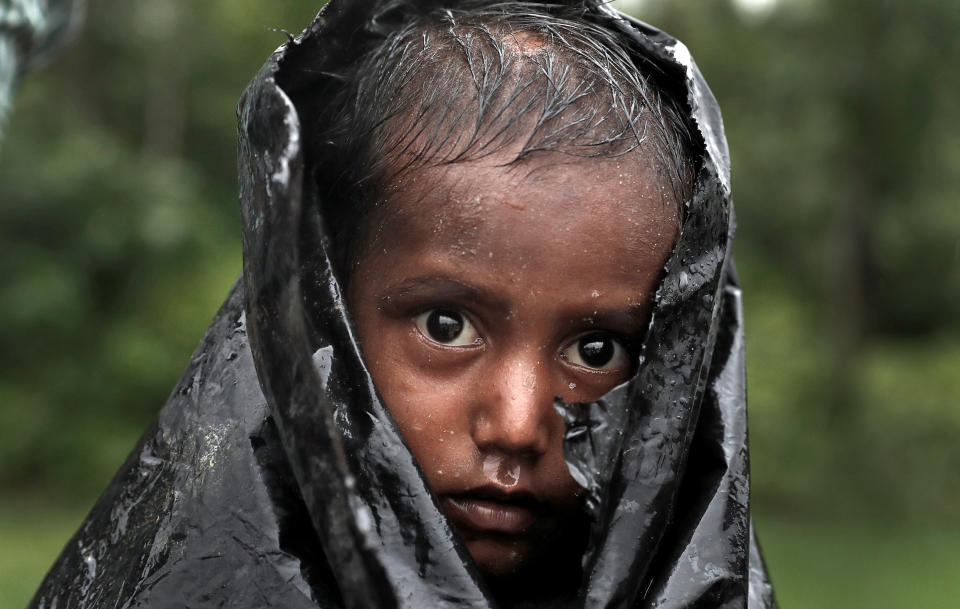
294, 2, 696, 280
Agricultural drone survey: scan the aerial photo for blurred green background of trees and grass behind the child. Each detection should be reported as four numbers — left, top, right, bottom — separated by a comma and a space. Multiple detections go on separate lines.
0, 0, 960, 609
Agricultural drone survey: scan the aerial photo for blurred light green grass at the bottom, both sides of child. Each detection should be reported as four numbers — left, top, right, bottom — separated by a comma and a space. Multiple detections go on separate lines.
0, 502, 960, 609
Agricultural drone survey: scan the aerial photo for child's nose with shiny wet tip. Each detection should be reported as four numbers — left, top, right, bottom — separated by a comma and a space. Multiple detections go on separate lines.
472, 351, 563, 458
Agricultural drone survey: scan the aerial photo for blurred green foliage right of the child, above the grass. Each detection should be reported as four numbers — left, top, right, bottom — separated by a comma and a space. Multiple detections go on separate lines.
624, 0, 960, 526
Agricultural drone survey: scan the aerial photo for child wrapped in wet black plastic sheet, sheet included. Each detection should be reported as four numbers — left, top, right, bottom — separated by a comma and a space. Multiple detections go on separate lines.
35, 1, 773, 607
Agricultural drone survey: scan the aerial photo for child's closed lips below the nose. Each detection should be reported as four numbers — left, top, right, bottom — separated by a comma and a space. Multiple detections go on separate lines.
441, 491, 540, 535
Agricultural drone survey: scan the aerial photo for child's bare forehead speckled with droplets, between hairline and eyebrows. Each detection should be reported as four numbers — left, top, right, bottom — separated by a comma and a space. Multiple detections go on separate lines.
369, 151, 679, 278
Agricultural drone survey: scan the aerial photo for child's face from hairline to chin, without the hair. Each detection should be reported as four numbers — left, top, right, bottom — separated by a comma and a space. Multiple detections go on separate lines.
348, 147, 678, 575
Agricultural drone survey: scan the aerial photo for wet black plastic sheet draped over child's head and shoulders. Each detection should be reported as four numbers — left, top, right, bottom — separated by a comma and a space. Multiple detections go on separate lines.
32, 0, 775, 609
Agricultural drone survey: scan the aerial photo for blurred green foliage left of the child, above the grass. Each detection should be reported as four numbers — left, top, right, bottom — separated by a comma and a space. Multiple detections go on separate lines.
0, 0, 316, 503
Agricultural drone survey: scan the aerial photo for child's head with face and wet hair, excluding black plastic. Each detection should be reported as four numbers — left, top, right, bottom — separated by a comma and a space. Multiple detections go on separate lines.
295, 4, 695, 596
